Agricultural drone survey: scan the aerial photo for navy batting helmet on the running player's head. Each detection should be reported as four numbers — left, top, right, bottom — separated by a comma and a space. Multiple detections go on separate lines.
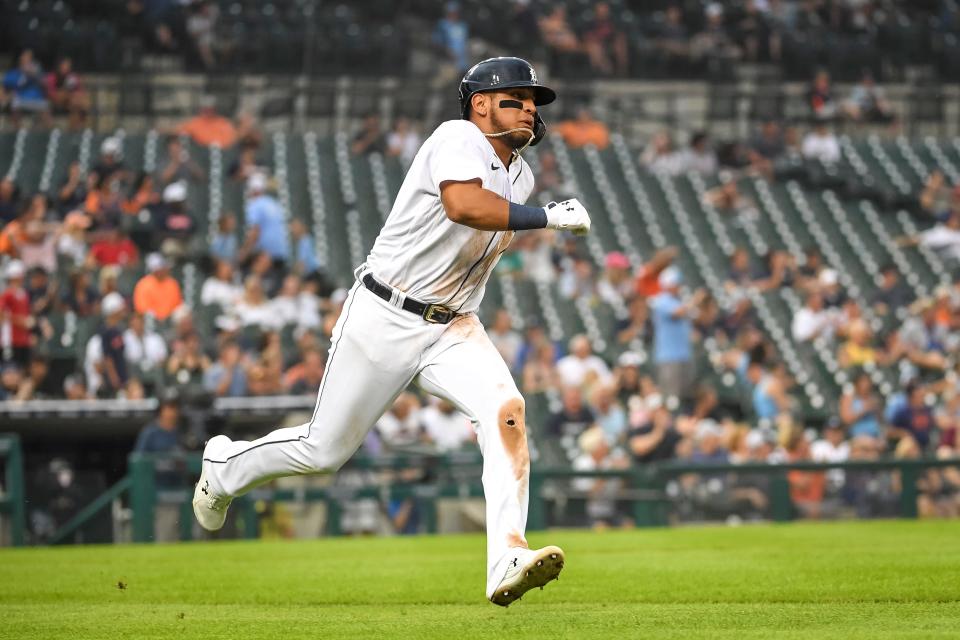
460, 57, 557, 145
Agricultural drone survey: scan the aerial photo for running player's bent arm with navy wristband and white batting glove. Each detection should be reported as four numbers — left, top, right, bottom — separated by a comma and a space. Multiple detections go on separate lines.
440, 178, 590, 235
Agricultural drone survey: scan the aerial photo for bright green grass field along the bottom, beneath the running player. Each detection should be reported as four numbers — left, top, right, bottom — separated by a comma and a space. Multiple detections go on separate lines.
0, 521, 960, 640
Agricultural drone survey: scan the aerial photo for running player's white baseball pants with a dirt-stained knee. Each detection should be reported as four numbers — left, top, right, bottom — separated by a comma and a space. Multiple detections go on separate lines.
204, 282, 530, 583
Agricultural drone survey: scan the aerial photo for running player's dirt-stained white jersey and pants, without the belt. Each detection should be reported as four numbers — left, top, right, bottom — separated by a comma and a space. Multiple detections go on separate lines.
205, 120, 533, 597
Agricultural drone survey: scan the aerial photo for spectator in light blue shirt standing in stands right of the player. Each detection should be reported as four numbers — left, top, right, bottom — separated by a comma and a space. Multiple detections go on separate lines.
650, 267, 705, 398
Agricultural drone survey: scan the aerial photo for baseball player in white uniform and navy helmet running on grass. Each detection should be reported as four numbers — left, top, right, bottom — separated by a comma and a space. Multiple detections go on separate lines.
193, 57, 590, 606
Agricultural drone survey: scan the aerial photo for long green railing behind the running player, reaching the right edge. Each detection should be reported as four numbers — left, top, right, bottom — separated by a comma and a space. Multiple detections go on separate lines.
118, 453, 960, 542
